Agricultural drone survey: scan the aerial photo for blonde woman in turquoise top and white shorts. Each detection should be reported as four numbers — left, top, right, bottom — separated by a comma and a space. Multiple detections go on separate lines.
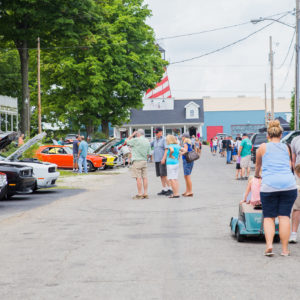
166, 135, 181, 198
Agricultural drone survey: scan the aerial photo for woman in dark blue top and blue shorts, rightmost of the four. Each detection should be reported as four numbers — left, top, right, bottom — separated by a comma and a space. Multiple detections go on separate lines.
181, 133, 194, 197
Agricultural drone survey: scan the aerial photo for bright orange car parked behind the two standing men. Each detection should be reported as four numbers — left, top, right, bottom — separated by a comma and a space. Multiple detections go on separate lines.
36, 145, 105, 172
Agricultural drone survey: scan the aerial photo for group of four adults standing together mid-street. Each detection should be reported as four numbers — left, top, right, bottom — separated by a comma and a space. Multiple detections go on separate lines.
125, 128, 202, 200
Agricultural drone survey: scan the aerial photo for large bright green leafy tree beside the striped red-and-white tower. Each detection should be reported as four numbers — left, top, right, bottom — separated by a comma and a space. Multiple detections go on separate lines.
42, 0, 166, 134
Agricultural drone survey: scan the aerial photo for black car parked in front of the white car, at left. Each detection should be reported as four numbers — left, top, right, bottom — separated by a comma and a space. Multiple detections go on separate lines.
0, 163, 36, 198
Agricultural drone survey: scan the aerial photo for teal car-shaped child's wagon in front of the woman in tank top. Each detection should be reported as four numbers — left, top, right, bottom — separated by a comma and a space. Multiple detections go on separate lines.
230, 203, 279, 242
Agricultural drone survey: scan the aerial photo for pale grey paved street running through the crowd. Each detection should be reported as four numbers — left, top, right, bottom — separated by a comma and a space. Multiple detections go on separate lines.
0, 147, 300, 300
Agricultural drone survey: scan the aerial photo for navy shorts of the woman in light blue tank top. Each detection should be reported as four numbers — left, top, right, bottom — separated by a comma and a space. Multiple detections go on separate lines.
260, 189, 298, 218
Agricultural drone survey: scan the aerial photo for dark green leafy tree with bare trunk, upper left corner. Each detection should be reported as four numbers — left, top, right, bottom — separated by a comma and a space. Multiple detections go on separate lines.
0, 0, 95, 133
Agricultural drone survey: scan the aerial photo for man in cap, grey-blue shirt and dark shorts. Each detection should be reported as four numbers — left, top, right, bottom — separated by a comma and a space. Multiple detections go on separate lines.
151, 127, 173, 196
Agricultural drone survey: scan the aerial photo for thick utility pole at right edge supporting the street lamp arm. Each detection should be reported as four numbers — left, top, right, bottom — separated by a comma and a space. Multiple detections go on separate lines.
294, 0, 300, 130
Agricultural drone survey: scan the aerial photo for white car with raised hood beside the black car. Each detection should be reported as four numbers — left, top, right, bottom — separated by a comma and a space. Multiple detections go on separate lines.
0, 133, 59, 190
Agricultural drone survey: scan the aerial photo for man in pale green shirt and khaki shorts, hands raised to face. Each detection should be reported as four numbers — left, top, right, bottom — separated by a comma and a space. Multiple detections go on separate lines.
126, 129, 151, 200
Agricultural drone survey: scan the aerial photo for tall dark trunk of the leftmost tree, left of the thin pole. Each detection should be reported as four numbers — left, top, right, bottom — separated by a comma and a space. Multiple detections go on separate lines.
16, 41, 30, 136
